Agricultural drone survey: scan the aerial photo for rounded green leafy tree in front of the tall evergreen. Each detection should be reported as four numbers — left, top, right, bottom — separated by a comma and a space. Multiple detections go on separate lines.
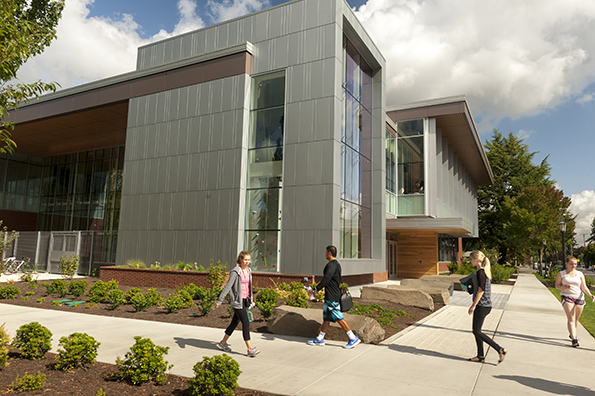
501, 184, 576, 266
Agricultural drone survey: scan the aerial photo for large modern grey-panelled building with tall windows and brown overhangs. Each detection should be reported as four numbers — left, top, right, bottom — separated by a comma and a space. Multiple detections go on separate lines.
0, 0, 490, 281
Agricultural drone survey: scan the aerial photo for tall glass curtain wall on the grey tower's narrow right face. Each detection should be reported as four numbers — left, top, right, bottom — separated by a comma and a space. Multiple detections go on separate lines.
339, 36, 372, 258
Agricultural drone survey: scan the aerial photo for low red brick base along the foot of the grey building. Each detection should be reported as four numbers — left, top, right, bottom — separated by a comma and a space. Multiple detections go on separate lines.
99, 266, 388, 288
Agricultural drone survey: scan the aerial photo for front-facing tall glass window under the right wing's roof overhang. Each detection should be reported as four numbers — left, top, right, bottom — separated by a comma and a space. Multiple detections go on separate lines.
397, 119, 425, 215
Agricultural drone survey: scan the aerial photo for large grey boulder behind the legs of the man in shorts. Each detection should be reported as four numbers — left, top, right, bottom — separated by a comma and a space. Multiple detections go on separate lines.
267, 305, 385, 344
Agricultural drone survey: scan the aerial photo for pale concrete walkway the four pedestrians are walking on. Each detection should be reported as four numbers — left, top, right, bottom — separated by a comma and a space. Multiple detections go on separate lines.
0, 272, 595, 396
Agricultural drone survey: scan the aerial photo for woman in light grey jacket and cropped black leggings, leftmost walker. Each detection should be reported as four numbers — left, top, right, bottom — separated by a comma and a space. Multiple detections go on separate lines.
216, 251, 260, 357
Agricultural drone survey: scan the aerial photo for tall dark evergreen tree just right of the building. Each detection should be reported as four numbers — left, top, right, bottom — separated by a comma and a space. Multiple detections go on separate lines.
477, 129, 554, 262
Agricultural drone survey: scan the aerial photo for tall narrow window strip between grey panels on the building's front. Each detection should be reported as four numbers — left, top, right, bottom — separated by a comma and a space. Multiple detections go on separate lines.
245, 72, 285, 272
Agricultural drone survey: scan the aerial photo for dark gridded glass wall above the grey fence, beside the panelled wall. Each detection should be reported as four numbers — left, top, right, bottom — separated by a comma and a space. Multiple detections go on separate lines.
37, 146, 124, 233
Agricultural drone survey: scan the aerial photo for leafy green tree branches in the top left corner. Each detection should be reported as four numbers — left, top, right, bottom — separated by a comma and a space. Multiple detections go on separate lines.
0, 0, 64, 153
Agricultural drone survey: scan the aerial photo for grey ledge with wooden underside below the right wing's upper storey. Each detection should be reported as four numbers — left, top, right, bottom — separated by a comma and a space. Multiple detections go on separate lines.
386, 217, 473, 237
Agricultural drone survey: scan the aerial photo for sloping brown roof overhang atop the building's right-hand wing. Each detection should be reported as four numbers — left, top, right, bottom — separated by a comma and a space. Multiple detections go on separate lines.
386, 96, 494, 186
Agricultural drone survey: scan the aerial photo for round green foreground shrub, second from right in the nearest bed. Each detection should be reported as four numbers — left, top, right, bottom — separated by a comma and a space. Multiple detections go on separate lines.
115, 336, 173, 385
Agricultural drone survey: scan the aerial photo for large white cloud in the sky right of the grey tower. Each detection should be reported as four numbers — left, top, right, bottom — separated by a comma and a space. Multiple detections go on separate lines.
357, 0, 595, 126
